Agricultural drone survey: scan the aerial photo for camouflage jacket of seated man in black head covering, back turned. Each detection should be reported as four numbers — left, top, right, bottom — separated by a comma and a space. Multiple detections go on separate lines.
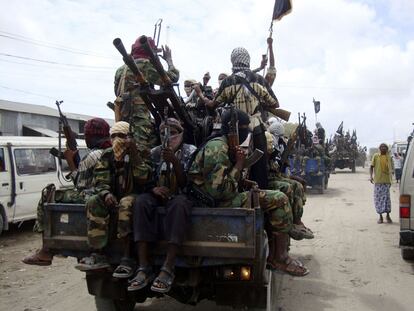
188, 136, 241, 202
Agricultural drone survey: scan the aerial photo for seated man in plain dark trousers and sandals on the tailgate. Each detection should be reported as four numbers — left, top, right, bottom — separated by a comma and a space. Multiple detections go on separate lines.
128, 118, 196, 293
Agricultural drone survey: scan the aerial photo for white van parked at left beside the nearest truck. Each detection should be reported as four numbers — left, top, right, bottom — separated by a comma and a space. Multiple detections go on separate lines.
0, 136, 86, 233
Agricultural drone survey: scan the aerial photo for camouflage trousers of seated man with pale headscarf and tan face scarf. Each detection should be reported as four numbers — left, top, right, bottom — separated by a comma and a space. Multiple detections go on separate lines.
86, 195, 135, 249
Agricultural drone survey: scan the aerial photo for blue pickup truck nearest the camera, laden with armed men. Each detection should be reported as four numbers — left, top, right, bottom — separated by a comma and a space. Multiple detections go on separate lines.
43, 203, 280, 311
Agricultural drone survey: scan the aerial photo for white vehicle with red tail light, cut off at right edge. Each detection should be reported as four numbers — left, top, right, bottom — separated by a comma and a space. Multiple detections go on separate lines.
400, 144, 414, 259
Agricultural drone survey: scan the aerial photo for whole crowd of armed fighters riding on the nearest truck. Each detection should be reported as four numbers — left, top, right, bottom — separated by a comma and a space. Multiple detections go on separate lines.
23, 38, 313, 293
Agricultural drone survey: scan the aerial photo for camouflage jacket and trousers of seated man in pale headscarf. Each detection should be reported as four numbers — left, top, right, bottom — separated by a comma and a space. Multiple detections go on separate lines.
86, 148, 148, 249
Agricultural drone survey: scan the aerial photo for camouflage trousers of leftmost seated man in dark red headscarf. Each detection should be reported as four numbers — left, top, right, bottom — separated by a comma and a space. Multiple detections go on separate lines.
33, 184, 87, 233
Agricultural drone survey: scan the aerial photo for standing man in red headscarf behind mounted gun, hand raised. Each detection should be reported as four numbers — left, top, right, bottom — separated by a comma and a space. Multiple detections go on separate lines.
114, 36, 179, 190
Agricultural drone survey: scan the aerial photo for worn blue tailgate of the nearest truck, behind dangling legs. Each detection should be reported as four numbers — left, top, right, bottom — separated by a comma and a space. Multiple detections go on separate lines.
43, 203, 263, 259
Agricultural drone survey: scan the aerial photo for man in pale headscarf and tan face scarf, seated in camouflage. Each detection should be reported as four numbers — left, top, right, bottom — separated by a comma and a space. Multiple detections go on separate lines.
75, 121, 148, 278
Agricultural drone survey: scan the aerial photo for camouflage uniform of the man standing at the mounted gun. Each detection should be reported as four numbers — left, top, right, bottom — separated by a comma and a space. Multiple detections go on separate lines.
115, 58, 179, 183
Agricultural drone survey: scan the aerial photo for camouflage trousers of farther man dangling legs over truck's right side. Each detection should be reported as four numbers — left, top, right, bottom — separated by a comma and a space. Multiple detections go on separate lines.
269, 176, 306, 223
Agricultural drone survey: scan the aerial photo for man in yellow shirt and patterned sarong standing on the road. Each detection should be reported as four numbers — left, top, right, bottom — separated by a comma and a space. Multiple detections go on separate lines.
369, 143, 392, 224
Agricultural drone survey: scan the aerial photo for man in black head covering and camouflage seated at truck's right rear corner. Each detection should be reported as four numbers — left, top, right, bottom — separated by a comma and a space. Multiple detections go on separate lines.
188, 110, 309, 276
